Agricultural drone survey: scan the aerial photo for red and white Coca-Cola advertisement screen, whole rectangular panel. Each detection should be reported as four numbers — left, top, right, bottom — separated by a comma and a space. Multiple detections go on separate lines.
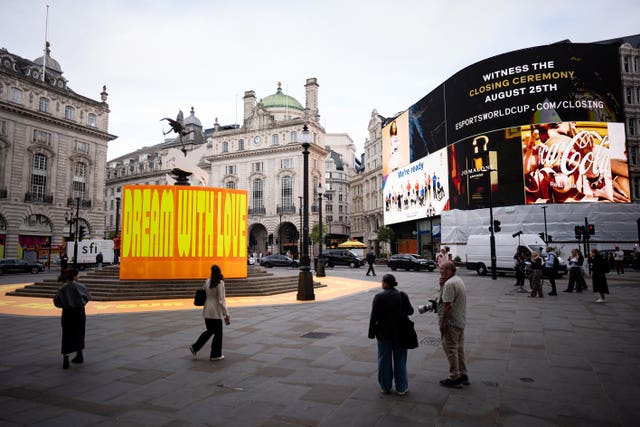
522, 122, 631, 203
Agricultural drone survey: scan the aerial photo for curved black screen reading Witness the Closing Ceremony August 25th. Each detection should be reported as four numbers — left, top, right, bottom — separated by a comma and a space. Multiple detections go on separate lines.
445, 43, 624, 144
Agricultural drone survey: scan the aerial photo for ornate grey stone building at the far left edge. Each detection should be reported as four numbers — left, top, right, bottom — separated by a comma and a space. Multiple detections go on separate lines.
0, 43, 116, 260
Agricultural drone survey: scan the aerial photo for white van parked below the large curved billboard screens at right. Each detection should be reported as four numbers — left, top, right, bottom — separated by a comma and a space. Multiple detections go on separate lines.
466, 233, 567, 276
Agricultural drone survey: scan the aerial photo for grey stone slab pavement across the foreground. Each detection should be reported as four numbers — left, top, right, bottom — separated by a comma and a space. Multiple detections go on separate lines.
0, 267, 640, 427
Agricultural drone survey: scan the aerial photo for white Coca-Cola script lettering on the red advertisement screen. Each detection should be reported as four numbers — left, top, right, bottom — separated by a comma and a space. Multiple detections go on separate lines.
538, 130, 611, 176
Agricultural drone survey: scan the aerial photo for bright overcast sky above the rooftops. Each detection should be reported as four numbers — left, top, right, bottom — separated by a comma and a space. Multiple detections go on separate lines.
0, 0, 640, 159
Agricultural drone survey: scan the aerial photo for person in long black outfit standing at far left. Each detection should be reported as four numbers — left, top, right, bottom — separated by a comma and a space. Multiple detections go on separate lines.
53, 268, 91, 369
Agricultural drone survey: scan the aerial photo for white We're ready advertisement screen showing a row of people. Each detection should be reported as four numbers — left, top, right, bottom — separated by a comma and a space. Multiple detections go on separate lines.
384, 149, 449, 224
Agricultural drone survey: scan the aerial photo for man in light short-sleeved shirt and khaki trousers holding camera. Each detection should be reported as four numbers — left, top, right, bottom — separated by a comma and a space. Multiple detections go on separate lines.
437, 261, 469, 388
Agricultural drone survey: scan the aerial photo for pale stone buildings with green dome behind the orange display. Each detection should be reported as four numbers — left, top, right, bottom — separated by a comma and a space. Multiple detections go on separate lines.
105, 78, 355, 256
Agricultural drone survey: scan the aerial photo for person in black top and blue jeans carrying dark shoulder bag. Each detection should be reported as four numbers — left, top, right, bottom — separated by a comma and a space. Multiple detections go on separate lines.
369, 274, 413, 396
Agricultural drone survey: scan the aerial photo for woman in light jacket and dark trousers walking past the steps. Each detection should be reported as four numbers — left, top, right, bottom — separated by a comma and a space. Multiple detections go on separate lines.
189, 264, 230, 360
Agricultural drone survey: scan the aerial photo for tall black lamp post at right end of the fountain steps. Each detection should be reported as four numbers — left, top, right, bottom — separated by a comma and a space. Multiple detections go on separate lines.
297, 125, 316, 301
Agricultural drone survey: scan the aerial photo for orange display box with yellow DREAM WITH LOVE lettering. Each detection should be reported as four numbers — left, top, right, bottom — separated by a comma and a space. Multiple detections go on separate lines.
120, 185, 247, 280
